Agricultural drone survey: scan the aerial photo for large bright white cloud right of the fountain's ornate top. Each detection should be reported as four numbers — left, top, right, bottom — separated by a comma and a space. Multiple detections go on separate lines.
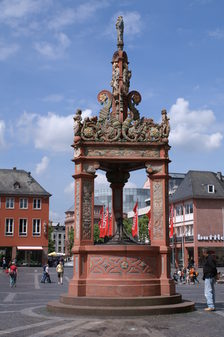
169, 98, 223, 150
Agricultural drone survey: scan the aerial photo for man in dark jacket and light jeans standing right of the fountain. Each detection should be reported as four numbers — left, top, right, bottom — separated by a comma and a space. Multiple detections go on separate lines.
202, 249, 217, 311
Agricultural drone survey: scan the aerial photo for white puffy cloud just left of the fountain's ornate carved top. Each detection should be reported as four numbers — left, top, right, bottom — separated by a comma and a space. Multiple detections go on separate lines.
17, 109, 92, 152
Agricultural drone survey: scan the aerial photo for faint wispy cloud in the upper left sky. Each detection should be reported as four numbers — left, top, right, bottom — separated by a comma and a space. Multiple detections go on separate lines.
34, 33, 71, 59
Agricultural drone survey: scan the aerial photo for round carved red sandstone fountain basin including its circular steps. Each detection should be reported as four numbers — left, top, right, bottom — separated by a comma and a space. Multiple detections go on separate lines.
47, 245, 194, 316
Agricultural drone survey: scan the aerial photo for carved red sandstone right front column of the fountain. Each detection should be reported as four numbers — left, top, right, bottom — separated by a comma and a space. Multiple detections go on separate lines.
146, 161, 175, 295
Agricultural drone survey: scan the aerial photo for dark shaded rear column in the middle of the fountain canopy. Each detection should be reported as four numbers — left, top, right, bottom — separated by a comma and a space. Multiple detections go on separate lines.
106, 170, 130, 233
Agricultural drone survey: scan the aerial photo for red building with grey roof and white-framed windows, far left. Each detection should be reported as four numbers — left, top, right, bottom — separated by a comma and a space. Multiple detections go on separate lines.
0, 168, 51, 265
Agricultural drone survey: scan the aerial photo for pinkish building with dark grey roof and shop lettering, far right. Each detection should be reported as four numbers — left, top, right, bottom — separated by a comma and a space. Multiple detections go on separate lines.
170, 171, 224, 266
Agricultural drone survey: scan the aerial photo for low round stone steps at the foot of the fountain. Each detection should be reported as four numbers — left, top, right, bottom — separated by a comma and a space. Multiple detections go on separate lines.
47, 294, 194, 317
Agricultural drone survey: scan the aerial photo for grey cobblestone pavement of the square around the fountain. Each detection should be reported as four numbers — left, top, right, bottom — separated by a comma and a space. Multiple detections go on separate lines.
0, 267, 224, 337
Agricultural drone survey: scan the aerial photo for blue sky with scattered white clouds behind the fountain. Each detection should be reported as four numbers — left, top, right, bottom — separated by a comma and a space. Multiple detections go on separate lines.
0, 0, 224, 221
